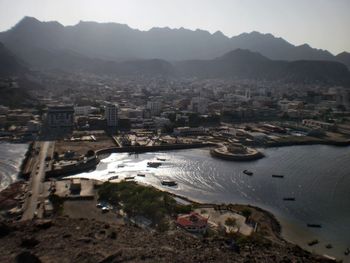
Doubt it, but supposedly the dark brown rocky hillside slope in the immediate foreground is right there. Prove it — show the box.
[0,217,334,263]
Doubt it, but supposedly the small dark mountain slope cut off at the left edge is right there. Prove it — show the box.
[0,43,25,77]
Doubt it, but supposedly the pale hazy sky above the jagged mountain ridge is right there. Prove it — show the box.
[0,0,350,54]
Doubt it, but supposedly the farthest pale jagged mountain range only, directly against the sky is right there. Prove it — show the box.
[0,17,348,67]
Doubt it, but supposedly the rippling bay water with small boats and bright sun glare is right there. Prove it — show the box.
[67,145,350,262]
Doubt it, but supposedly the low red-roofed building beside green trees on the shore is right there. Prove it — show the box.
[176,212,208,233]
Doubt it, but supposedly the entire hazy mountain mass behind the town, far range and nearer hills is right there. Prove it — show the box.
[0,17,349,84]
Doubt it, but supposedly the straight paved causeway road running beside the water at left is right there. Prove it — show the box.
[22,141,53,220]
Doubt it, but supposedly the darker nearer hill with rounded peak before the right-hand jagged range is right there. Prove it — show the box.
[174,49,350,85]
